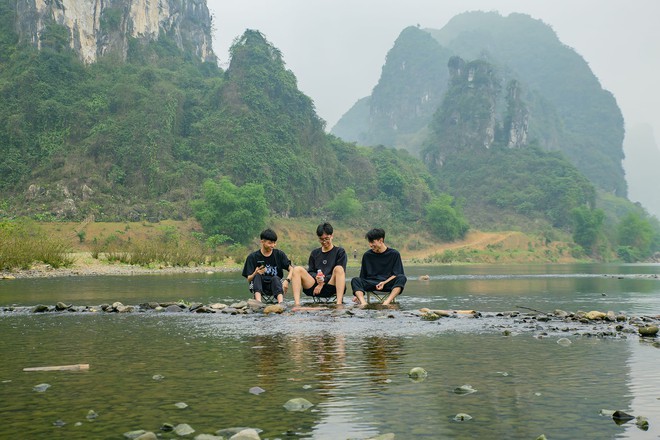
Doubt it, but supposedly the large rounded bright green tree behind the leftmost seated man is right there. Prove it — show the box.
[191,177,268,243]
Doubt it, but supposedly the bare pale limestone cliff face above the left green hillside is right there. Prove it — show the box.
[16,0,215,63]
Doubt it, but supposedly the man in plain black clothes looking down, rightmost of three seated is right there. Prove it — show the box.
[351,228,407,305]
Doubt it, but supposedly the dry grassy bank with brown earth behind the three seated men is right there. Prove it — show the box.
[11,218,575,267]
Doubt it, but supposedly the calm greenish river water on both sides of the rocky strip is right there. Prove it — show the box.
[0,265,660,440]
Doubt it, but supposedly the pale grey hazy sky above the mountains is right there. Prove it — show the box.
[208,0,660,139]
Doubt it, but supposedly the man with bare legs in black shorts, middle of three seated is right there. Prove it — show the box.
[291,223,348,306]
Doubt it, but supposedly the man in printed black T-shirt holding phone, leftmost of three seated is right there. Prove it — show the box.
[242,229,293,303]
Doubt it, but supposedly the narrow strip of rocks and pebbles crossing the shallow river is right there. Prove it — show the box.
[0,300,660,342]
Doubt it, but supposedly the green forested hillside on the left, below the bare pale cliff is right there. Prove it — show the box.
[0,10,433,227]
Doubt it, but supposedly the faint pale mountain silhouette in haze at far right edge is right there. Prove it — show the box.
[623,124,660,218]
